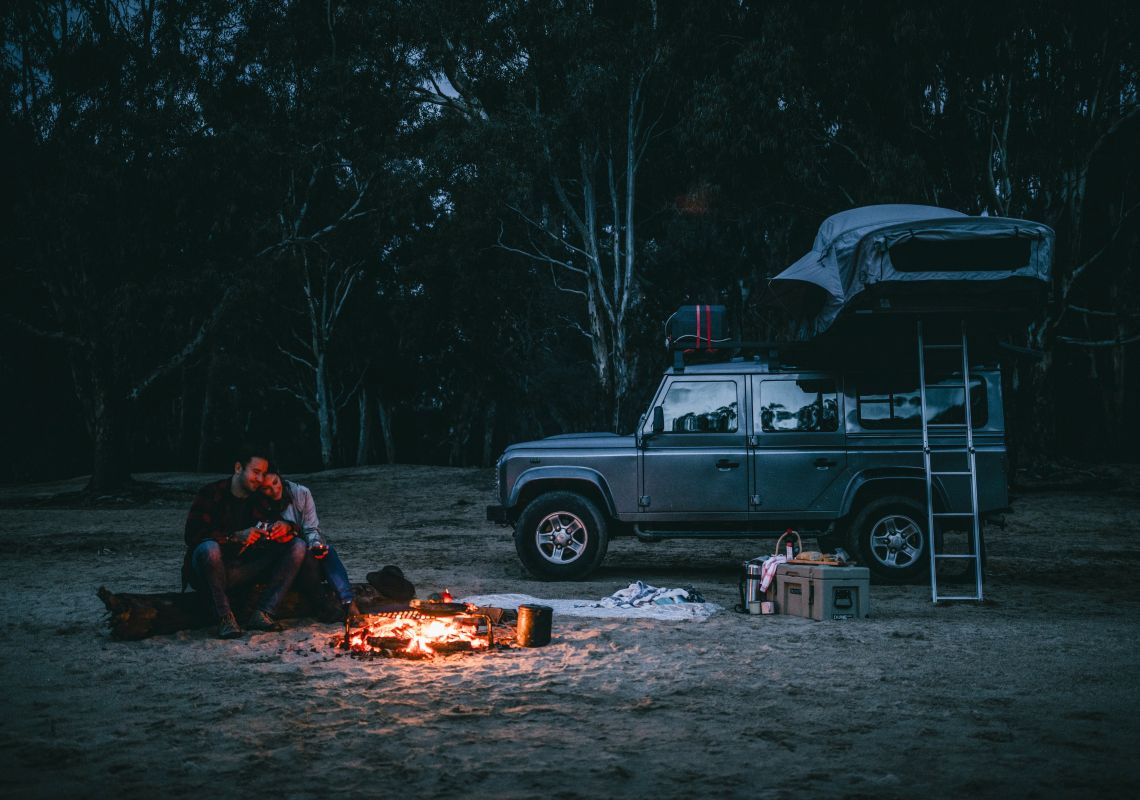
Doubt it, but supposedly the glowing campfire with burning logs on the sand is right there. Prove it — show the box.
[333,603,508,659]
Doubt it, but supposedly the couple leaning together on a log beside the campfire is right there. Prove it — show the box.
[182,447,357,639]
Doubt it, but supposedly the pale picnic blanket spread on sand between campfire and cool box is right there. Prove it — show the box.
[463,581,722,620]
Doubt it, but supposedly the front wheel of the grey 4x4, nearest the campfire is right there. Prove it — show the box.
[514,491,609,580]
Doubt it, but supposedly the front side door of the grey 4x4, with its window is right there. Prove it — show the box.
[640,375,748,519]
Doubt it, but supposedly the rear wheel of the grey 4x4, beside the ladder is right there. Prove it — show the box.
[852,496,930,583]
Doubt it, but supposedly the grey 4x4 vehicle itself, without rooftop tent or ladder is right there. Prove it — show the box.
[487,350,1008,580]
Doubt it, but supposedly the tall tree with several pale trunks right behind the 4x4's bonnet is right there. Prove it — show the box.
[403,2,698,427]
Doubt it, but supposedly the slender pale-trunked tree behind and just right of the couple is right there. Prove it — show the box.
[230,2,428,468]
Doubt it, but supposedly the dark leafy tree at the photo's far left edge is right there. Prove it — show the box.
[0,0,241,492]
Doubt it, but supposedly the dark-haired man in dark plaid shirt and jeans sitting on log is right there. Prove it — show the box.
[182,447,307,639]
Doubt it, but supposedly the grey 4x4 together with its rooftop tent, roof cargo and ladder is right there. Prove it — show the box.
[487,205,1055,583]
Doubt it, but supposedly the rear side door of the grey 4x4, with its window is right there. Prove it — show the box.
[751,375,847,514]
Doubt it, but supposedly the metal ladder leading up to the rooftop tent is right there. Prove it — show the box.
[918,320,983,603]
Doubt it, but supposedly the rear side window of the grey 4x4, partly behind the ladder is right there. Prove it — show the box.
[856,377,988,430]
